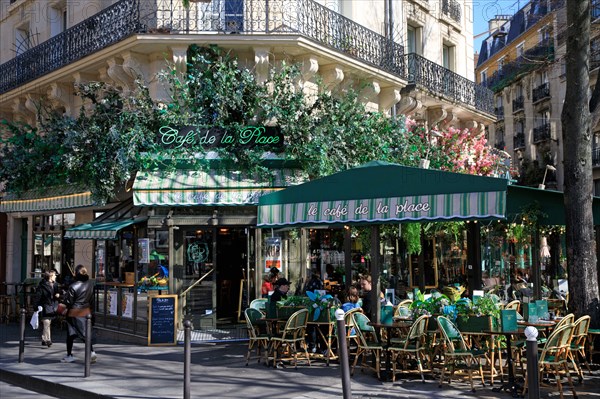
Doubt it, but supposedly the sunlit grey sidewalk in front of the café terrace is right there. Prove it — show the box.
[0,323,600,399]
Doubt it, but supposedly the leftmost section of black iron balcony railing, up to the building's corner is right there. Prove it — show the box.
[0,0,140,94]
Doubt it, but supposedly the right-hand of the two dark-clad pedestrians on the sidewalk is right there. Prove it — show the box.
[62,265,97,363]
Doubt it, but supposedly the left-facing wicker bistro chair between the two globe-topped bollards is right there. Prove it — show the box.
[388,315,429,383]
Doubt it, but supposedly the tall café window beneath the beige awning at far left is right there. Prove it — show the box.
[33,213,75,277]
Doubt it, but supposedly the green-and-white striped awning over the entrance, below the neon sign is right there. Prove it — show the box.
[133,169,305,206]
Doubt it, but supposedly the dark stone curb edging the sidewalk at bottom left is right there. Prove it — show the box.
[0,369,113,399]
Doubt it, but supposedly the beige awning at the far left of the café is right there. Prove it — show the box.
[0,186,94,213]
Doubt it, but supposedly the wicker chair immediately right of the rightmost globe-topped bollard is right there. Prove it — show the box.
[523,324,577,399]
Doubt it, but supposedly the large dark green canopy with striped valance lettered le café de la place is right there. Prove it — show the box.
[258,161,508,227]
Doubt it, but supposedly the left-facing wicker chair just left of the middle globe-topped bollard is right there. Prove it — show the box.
[271,309,310,369]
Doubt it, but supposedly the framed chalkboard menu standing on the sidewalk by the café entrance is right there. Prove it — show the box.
[148,295,177,345]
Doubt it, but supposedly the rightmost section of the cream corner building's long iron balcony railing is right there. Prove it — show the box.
[405,53,494,115]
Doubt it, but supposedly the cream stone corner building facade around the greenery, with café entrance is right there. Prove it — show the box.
[0,0,495,338]
